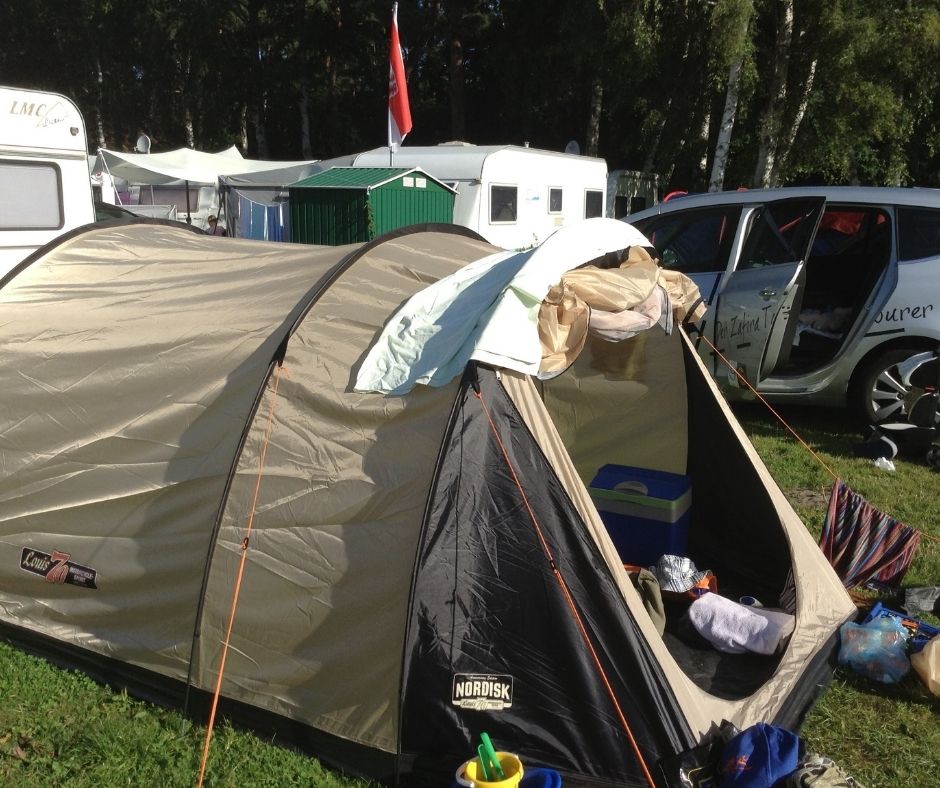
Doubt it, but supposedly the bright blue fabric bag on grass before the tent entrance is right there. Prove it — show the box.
[718,722,803,788]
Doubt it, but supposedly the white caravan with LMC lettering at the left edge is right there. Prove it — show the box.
[0,87,95,280]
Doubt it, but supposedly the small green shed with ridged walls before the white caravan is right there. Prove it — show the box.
[288,167,456,246]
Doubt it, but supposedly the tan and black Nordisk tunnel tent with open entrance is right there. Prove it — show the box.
[0,220,854,785]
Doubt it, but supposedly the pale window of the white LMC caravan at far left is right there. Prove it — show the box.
[0,162,64,230]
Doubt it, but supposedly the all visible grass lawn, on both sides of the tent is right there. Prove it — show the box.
[0,405,940,788]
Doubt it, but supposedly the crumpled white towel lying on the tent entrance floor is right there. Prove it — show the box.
[689,594,796,654]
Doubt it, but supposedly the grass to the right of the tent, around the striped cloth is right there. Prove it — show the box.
[735,404,940,788]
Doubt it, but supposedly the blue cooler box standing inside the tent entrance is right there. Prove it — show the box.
[588,465,692,566]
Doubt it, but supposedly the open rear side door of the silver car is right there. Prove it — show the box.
[714,197,826,386]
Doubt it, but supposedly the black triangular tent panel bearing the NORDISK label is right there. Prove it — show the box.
[402,368,692,785]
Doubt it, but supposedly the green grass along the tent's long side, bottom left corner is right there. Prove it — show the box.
[0,643,368,788]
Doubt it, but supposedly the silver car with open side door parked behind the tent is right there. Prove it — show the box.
[624,187,940,423]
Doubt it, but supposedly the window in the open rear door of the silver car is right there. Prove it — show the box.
[738,200,819,271]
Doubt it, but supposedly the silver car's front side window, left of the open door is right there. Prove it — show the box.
[634,205,741,274]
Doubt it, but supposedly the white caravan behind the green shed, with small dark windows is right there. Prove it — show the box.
[334,142,607,249]
